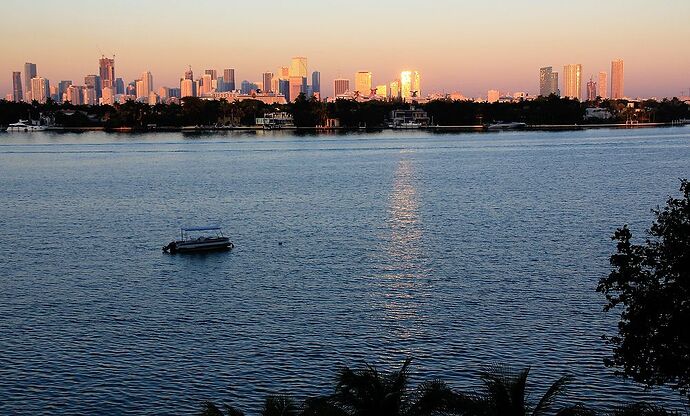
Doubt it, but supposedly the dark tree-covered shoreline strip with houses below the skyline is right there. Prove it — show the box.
[0,94,690,131]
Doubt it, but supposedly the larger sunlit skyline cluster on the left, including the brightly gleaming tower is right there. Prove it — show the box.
[6,56,421,105]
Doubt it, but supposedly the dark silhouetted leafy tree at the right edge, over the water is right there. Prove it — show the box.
[597,180,690,395]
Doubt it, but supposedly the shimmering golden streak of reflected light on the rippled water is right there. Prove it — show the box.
[381,159,428,338]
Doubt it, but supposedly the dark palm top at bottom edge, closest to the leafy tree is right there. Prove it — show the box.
[468,366,588,416]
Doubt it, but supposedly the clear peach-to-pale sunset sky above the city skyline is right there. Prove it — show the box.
[0,0,690,97]
